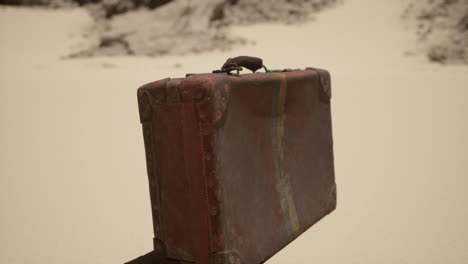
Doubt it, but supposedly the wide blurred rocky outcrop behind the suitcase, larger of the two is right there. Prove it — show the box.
[0,0,340,57]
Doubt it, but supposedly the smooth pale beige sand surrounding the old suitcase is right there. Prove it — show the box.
[0,0,468,264]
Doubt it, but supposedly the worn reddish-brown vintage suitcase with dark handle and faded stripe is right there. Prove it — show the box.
[138,57,336,264]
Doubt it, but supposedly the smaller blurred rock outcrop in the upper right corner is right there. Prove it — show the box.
[404,0,468,63]
